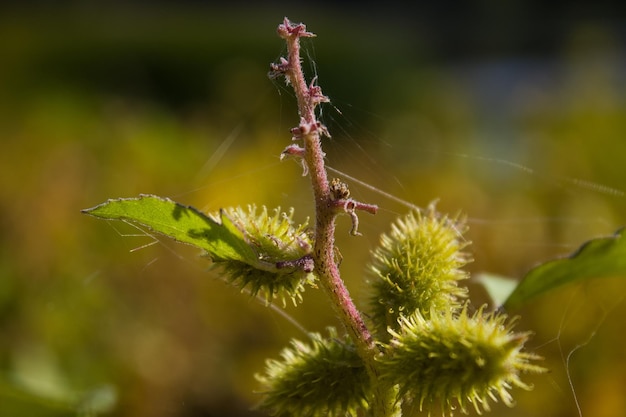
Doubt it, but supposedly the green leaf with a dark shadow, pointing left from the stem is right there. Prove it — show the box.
[83,195,258,264]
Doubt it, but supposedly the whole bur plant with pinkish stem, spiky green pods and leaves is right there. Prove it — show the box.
[84,19,626,417]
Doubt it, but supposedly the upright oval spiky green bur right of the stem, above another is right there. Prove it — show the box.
[370,208,470,338]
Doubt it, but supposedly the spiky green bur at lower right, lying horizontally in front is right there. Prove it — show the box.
[381,308,545,416]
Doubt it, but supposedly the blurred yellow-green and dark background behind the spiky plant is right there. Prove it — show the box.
[0,1,626,417]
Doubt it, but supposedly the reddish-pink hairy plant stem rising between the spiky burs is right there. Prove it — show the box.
[272,18,400,417]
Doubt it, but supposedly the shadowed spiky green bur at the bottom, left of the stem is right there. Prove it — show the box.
[257,328,370,417]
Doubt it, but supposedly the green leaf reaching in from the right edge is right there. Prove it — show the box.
[503,229,626,310]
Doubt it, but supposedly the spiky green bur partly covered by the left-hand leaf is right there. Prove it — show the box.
[216,205,315,304]
